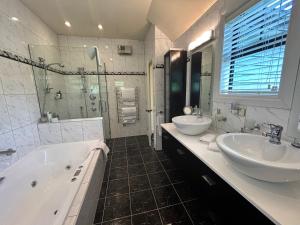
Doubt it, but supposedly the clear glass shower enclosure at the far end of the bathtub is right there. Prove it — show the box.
[29,45,111,138]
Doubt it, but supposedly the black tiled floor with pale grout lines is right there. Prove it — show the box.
[94,136,214,225]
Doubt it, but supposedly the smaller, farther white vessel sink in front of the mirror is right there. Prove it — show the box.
[172,115,212,135]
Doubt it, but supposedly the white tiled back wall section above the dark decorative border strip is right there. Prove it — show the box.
[58,35,144,72]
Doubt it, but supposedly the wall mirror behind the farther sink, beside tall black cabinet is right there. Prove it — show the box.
[190,45,213,115]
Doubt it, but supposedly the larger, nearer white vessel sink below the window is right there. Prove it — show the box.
[217,133,300,182]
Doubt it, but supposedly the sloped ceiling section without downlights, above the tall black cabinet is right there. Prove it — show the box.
[148,0,217,41]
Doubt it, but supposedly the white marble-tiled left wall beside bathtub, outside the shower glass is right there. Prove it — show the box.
[0,0,57,170]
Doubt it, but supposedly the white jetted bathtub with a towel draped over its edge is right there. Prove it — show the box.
[0,140,108,225]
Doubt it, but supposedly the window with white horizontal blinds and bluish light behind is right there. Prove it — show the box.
[220,0,293,96]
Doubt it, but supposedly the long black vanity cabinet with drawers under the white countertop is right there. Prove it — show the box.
[162,129,273,225]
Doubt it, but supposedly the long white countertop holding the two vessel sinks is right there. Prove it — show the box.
[161,123,300,225]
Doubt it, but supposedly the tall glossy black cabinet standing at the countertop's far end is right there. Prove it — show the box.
[164,49,187,122]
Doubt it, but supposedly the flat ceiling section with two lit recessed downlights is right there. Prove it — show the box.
[21,0,151,40]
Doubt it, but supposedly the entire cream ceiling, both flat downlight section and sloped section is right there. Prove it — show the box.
[21,0,216,40]
